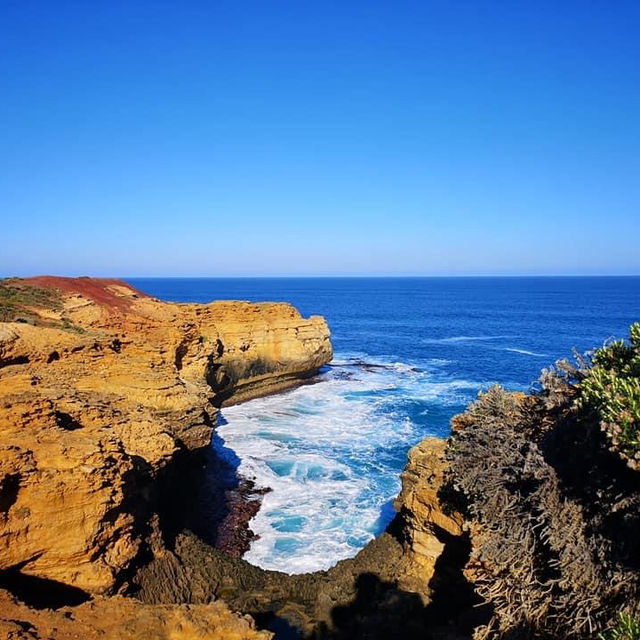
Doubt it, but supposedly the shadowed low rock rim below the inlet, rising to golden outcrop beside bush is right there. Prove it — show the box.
[133,438,469,639]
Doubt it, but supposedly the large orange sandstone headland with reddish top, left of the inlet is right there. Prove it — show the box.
[0,277,332,594]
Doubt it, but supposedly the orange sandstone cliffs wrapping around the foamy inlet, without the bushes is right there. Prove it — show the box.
[0,277,468,640]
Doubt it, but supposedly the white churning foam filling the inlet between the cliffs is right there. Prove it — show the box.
[218,354,478,573]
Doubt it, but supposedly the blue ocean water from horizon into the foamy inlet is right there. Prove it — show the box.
[128,277,640,573]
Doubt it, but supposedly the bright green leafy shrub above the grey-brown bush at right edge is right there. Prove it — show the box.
[578,323,640,469]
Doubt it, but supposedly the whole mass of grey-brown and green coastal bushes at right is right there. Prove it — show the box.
[448,324,640,639]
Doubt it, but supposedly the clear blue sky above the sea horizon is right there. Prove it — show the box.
[0,0,640,276]
